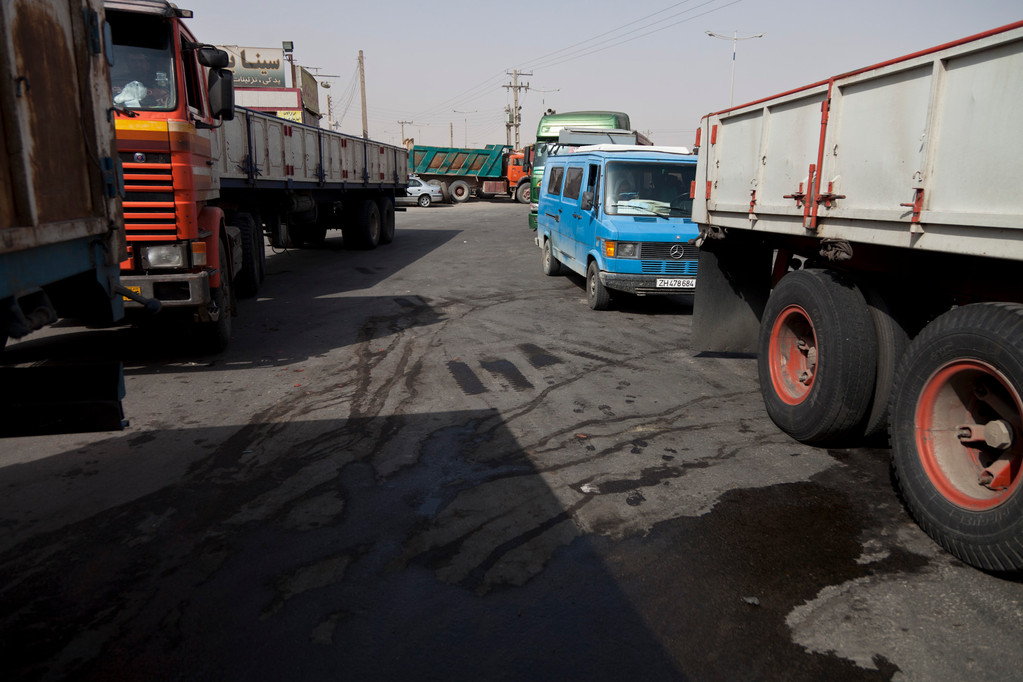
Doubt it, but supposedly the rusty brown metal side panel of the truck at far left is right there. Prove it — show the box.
[0,0,124,253]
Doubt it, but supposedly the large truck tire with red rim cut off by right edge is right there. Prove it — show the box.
[891,304,1023,574]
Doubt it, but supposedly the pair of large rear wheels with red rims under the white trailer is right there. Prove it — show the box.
[758,270,1023,573]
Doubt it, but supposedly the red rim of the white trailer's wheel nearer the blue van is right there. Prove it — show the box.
[767,306,818,405]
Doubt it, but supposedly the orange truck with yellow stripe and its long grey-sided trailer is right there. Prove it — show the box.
[105,0,408,352]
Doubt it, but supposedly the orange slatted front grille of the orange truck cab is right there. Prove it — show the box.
[121,152,177,241]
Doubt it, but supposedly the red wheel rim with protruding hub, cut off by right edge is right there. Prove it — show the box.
[915,360,1023,511]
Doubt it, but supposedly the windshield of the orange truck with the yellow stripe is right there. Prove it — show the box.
[107,11,177,111]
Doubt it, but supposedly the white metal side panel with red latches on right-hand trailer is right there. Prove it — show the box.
[694,25,1023,260]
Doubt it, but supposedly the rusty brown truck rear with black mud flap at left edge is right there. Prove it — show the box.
[0,0,126,437]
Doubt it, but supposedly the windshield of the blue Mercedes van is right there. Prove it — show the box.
[604,162,697,218]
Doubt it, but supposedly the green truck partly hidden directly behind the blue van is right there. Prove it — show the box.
[526,111,651,231]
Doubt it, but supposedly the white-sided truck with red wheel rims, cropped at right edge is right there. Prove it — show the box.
[693,22,1023,573]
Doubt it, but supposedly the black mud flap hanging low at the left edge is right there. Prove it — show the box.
[0,362,128,438]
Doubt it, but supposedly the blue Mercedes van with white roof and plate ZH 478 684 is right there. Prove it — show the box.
[536,149,700,310]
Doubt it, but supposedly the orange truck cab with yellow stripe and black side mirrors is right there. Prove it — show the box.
[105,0,241,351]
